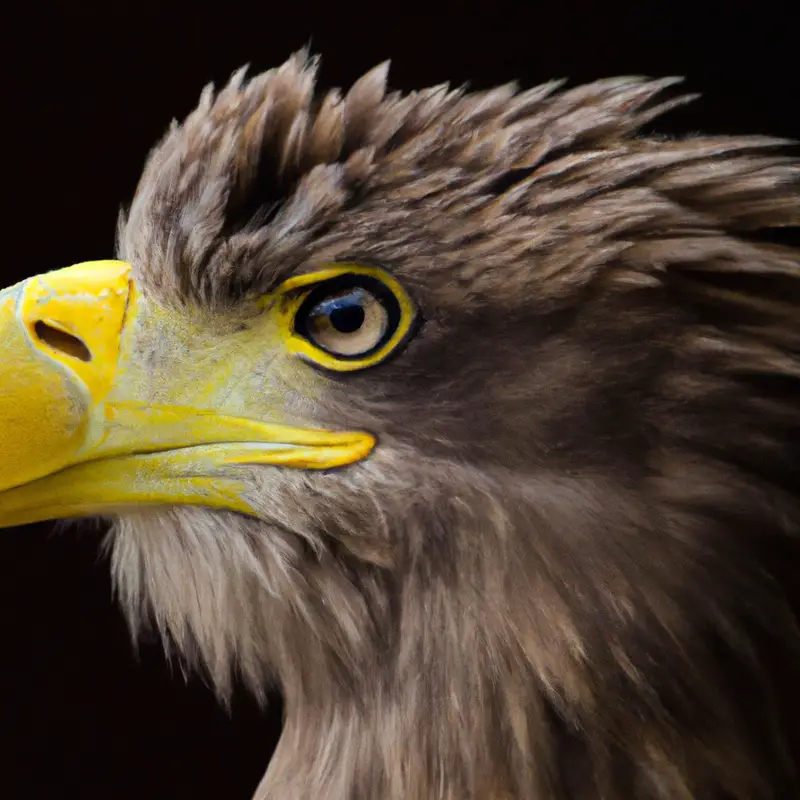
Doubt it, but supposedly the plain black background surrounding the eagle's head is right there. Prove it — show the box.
[0,0,800,800]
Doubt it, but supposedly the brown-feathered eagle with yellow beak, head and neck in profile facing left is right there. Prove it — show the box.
[0,50,800,800]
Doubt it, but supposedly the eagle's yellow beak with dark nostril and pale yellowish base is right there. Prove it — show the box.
[0,261,375,527]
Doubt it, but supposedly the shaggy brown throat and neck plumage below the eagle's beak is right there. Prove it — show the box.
[114,454,786,800]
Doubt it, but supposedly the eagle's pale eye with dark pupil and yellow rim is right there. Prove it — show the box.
[278,264,416,372]
